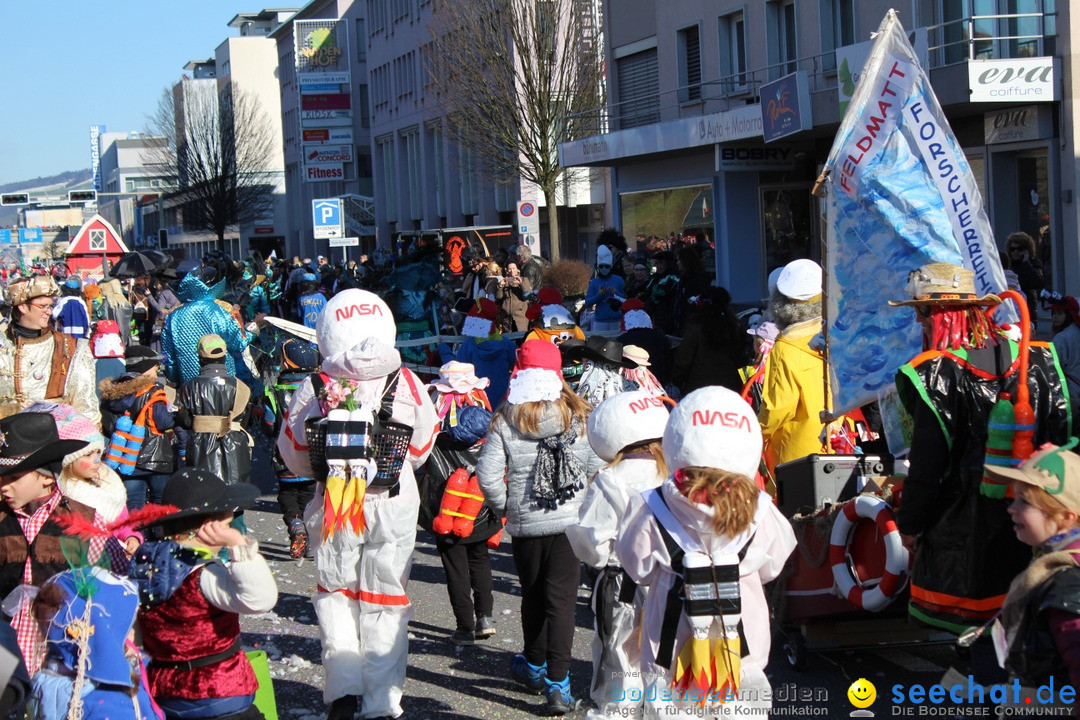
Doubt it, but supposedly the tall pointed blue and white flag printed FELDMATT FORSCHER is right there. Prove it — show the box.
[824,10,1005,415]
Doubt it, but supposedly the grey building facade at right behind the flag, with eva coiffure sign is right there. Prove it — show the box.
[562,0,1067,300]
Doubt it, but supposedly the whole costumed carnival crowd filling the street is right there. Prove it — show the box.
[0,232,1080,720]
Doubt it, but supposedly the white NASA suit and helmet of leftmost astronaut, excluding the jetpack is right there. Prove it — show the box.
[278,289,438,718]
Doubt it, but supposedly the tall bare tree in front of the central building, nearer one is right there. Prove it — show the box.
[423,0,603,261]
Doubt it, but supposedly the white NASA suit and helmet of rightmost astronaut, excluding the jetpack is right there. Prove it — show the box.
[616,386,795,719]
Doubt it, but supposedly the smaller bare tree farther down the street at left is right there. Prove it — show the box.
[144,80,274,249]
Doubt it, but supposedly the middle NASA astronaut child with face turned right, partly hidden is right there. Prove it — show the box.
[566,391,667,718]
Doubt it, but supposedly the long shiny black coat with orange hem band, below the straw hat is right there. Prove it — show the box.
[896,341,1070,630]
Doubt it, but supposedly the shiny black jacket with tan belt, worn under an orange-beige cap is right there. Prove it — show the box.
[176,364,252,485]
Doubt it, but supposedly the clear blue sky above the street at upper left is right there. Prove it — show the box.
[0,0,268,184]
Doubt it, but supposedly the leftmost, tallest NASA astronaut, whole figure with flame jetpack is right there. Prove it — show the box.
[278,288,438,720]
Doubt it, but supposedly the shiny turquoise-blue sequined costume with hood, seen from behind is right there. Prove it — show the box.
[161,272,262,395]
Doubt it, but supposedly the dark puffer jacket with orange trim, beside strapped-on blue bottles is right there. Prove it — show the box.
[97,376,176,476]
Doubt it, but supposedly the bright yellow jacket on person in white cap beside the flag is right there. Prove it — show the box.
[758,318,833,473]
